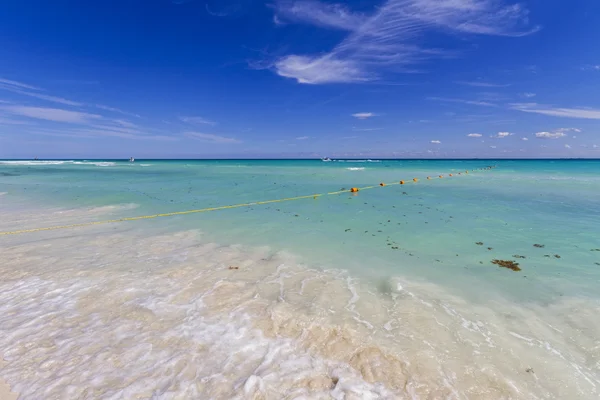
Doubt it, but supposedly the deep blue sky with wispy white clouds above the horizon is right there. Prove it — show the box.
[0,0,600,158]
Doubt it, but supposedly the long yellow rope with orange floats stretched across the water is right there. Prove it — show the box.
[0,168,488,236]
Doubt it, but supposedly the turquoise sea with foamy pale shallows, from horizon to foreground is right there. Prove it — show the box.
[0,160,600,399]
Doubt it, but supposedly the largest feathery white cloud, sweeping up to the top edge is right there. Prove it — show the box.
[272,0,539,84]
